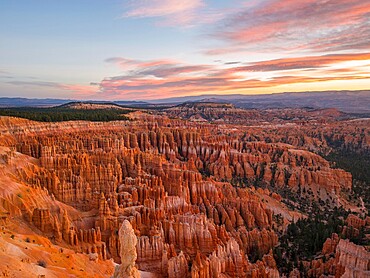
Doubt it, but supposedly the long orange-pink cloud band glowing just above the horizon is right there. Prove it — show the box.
[100,53,370,99]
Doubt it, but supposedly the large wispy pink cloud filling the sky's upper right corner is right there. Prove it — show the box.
[206,0,370,55]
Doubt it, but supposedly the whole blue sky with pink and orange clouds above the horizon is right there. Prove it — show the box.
[0,0,370,100]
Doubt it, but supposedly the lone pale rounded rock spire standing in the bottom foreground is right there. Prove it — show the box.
[113,220,140,278]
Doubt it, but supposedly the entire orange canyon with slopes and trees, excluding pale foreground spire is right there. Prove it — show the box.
[0,103,370,277]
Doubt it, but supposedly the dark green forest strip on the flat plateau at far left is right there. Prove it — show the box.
[0,107,132,122]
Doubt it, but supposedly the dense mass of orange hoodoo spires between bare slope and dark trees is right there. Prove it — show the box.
[0,112,366,277]
